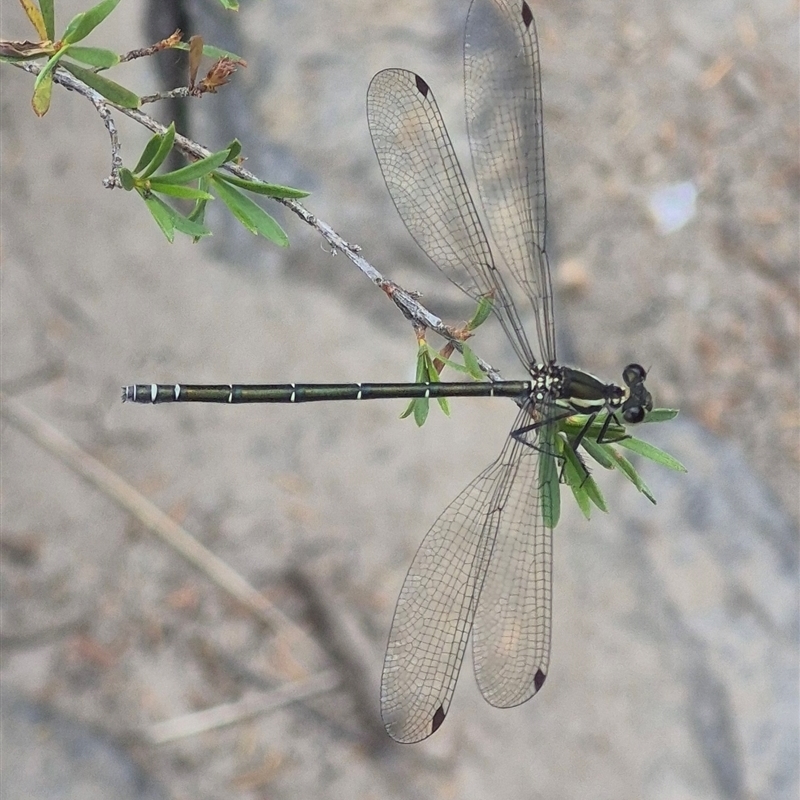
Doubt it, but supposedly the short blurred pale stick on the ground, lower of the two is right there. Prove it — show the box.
[142,671,340,744]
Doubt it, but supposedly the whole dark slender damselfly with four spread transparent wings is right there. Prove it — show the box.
[123,0,652,742]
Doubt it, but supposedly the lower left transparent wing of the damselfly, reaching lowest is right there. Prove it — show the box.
[381,410,550,742]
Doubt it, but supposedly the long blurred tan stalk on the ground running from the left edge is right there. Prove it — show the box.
[0,392,319,652]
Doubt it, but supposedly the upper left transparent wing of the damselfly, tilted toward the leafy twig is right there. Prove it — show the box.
[367,69,535,368]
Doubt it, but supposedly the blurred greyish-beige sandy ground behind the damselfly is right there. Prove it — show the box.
[0,0,800,800]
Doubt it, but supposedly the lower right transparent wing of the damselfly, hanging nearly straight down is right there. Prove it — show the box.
[472,410,558,708]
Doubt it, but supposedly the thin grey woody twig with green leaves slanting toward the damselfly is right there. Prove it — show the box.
[9,61,502,381]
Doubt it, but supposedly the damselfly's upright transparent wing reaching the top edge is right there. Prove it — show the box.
[464,0,556,361]
